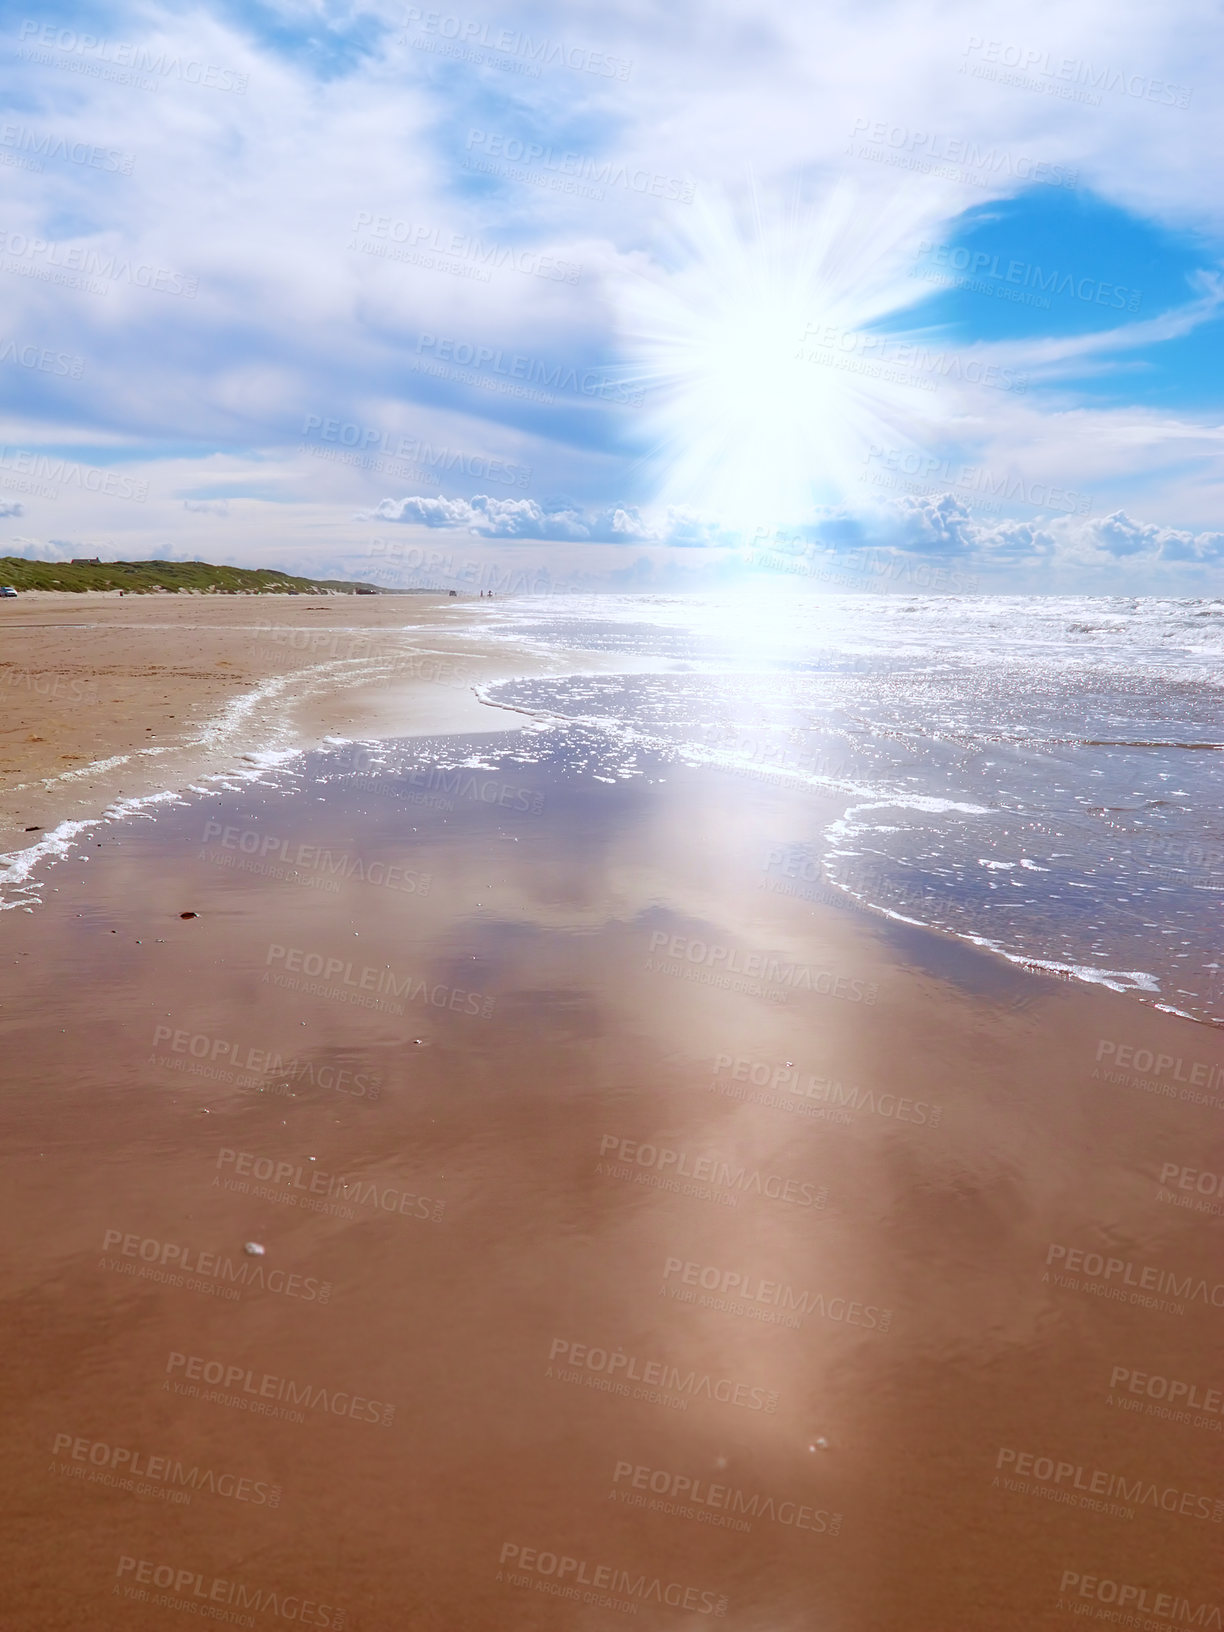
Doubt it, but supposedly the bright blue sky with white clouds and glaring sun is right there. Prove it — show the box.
[0,0,1224,596]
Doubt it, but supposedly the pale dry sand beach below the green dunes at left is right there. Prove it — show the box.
[0,592,535,852]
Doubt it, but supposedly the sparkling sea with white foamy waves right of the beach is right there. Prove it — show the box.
[453,592,1224,1023]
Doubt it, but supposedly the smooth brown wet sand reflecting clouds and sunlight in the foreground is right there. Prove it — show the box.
[0,736,1224,1632]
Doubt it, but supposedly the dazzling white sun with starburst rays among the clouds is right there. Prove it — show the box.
[617,186,947,535]
